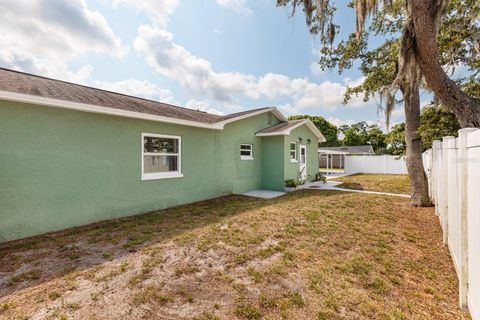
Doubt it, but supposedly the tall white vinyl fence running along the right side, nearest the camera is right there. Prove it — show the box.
[423,128,480,320]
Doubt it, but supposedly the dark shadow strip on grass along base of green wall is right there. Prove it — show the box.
[0,190,339,298]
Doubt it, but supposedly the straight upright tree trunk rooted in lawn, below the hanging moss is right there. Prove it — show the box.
[400,85,432,207]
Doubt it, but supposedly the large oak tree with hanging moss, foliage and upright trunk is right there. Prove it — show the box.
[277,0,480,206]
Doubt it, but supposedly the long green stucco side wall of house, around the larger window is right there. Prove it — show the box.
[0,101,284,242]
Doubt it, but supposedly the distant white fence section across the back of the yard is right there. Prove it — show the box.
[345,155,407,174]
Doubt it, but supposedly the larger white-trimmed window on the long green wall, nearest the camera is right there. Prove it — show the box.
[142,133,182,180]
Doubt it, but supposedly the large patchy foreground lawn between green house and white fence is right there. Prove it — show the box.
[0,190,468,319]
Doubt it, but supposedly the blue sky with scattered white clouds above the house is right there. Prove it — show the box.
[0,0,412,125]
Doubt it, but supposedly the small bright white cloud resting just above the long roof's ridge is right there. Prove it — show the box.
[93,79,178,104]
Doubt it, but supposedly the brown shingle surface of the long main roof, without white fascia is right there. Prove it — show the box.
[0,68,266,124]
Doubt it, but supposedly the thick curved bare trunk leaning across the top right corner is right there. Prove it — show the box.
[410,0,480,128]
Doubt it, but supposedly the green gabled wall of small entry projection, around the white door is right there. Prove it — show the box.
[284,125,319,180]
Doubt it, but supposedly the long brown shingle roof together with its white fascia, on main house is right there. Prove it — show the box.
[0,68,286,129]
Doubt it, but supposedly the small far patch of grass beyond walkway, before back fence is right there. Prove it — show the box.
[334,173,410,194]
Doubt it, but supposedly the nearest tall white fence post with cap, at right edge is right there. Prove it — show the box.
[457,128,476,309]
